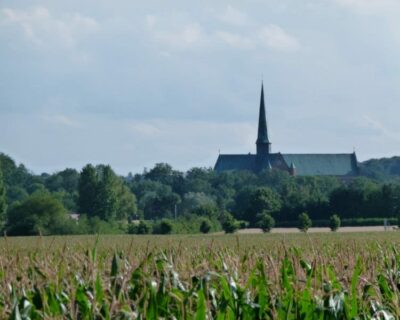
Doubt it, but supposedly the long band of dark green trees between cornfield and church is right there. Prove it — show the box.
[0,154,400,235]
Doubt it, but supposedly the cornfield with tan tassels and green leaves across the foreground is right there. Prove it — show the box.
[0,232,400,319]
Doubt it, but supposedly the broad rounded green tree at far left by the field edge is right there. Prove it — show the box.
[6,194,69,235]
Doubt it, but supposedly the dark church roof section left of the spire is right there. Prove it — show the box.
[214,154,256,171]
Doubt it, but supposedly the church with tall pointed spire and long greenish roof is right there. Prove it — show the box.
[214,85,358,178]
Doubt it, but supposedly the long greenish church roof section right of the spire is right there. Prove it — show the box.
[282,153,358,176]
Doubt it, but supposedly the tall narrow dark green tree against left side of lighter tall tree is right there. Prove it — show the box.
[78,164,98,217]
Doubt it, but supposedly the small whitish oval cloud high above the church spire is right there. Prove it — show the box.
[258,24,300,51]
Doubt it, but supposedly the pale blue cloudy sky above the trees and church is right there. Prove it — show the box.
[0,0,400,174]
